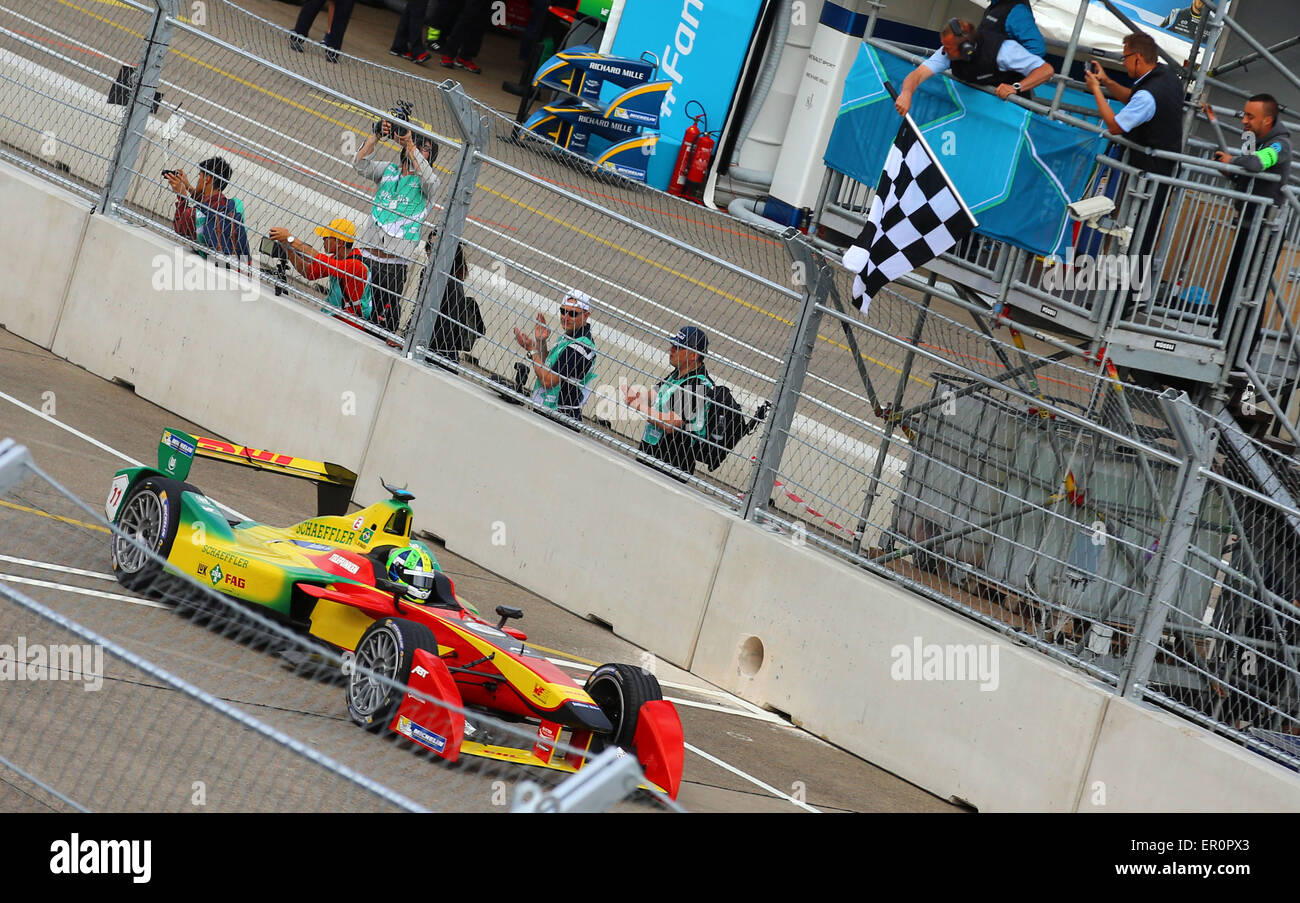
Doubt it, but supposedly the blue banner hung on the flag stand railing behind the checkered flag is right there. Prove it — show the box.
[826,44,1106,256]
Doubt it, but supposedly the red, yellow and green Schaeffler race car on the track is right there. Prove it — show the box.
[105,430,685,798]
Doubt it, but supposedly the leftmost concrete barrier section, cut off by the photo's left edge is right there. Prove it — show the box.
[0,166,91,348]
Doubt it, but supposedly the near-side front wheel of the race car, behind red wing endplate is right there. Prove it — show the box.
[347,617,438,731]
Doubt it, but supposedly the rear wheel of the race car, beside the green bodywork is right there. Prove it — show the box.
[112,477,192,592]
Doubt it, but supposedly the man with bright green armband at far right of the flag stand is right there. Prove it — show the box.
[1214,94,1291,328]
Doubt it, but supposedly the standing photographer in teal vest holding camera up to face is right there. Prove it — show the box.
[352,120,438,331]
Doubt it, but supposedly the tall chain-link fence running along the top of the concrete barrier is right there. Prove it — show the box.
[10,0,1300,779]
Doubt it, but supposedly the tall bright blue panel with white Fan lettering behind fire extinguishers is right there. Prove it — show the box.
[601,0,763,188]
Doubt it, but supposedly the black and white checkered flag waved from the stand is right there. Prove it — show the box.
[844,116,979,313]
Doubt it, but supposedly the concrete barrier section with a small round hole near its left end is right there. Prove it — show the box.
[692,522,1109,812]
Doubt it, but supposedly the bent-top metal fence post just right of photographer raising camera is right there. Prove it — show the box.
[402,83,491,357]
